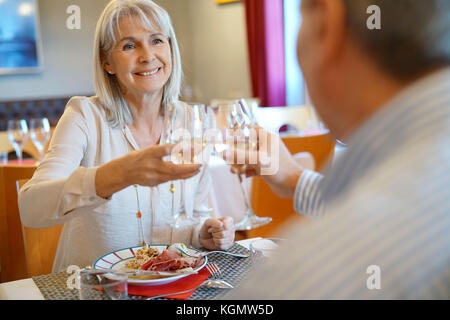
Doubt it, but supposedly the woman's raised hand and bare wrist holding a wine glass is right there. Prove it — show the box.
[95,144,201,198]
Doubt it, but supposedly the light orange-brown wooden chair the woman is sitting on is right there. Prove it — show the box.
[17,179,63,278]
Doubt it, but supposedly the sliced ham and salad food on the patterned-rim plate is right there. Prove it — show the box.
[121,243,203,274]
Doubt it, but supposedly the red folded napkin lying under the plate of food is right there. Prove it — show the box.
[128,268,210,300]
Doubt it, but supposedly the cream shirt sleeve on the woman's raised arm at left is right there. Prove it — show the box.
[18,98,109,228]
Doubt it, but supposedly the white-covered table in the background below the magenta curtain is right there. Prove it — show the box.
[254,106,320,132]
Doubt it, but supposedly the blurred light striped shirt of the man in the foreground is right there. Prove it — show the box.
[227,68,450,299]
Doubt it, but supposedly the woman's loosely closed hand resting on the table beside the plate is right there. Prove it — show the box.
[199,217,235,250]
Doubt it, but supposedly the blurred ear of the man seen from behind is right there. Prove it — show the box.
[315,0,347,65]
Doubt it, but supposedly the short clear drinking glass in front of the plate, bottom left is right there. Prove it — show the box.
[78,269,128,300]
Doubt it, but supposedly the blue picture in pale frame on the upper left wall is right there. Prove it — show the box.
[0,0,42,75]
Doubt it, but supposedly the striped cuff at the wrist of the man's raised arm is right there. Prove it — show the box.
[294,170,324,218]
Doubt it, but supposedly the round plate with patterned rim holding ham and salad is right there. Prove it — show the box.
[93,243,208,286]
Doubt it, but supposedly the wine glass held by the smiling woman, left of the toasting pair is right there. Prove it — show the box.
[163,104,203,229]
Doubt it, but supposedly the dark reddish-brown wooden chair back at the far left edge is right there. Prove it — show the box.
[0,164,36,282]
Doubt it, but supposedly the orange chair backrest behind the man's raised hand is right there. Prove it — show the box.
[246,132,335,238]
